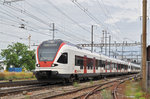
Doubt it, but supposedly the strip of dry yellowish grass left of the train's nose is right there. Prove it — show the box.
[0,72,35,80]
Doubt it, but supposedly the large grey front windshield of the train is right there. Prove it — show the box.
[38,42,60,61]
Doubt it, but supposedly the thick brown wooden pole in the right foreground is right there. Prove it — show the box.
[142,0,147,91]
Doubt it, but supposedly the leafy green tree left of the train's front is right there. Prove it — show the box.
[1,43,35,70]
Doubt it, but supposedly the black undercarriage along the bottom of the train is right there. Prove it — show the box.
[35,71,138,83]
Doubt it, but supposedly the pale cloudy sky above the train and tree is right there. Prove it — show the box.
[0,0,150,58]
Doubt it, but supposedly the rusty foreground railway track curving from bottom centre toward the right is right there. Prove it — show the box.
[36,75,139,99]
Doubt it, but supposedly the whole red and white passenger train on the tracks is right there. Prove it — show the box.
[35,40,141,81]
